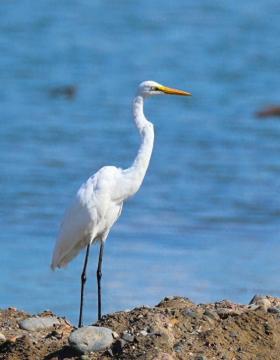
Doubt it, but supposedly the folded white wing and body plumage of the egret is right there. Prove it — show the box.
[51,166,123,269]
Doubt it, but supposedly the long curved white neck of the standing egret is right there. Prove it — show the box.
[122,95,154,197]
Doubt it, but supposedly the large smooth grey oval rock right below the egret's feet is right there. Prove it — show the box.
[68,326,114,353]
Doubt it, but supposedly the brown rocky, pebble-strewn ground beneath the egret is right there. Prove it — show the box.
[0,296,280,360]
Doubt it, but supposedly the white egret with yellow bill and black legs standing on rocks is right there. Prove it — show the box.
[51,81,191,327]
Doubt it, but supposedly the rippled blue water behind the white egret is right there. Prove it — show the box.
[0,0,280,322]
